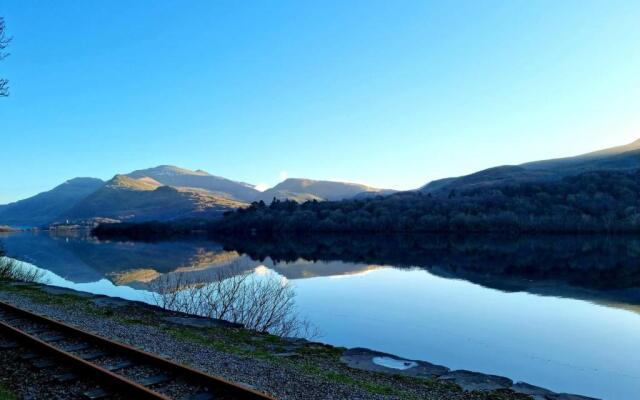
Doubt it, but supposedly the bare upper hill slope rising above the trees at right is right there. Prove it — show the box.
[419,140,640,194]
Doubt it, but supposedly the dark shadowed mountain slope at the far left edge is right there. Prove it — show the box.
[0,178,104,226]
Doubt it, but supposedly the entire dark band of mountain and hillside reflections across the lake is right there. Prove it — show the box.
[0,232,640,311]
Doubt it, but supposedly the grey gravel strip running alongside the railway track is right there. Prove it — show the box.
[0,282,528,400]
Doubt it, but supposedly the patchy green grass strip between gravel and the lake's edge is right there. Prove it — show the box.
[0,282,529,400]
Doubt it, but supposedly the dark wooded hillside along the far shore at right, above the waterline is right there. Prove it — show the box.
[209,171,640,234]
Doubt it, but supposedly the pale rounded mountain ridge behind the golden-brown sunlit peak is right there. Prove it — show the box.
[127,165,260,202]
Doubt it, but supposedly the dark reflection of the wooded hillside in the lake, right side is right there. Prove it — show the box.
[218,235,640,311]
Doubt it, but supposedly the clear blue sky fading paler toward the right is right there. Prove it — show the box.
[0,0,640,203]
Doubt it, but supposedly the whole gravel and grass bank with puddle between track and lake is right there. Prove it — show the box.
[0,283,600,400]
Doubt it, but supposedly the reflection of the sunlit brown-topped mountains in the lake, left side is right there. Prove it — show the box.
[0,232,252,287]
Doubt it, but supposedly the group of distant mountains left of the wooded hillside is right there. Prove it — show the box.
[0,165,393,227]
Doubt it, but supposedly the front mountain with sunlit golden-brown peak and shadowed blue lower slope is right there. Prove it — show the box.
[62,175,246,221]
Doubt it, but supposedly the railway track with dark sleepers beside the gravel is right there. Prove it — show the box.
[0,302,275,400]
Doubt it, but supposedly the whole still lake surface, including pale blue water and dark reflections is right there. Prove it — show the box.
[0,232,640,400]
